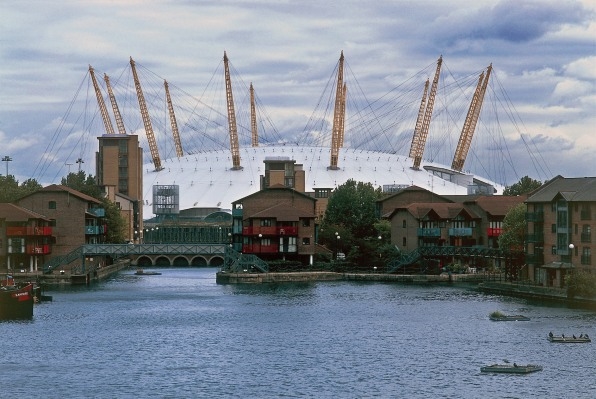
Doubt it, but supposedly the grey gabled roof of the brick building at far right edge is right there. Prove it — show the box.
[526,176,596,203]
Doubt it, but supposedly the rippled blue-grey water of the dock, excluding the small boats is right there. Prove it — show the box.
[0,268,596,398]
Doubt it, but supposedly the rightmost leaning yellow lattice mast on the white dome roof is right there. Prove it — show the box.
[451,64,493,172]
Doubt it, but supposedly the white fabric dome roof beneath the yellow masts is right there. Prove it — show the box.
[143,145,503,219]
